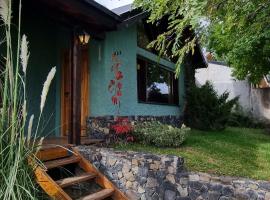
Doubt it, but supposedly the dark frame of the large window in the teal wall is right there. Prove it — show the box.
[136,55,180,106]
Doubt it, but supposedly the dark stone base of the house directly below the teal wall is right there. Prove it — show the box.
[86,115,183,139]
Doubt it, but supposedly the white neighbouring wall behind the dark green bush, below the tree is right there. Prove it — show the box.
[195,62,270,121]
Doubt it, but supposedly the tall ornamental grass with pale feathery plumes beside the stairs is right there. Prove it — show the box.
[0,0,56,200]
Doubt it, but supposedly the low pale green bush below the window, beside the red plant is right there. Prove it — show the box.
[133,121,190,147]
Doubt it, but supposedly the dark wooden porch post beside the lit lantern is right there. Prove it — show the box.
[69,32,81,145]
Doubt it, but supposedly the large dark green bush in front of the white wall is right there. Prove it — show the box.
[185,81,238,130]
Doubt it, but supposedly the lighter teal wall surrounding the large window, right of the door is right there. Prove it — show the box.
[90,25,184,116]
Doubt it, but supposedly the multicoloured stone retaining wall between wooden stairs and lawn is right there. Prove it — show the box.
[78,146,270,200]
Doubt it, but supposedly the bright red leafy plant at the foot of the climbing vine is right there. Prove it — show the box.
[111,117,134,142]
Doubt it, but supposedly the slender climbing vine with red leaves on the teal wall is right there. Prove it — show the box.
[108,51,124,114]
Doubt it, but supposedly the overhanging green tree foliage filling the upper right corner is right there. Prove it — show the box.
[135,0,270,83]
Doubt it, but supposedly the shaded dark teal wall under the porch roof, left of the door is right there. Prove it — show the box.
[22,16,70,136]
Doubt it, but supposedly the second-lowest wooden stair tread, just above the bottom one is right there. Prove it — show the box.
[55,173,96,188]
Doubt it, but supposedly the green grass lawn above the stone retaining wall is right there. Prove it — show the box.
[115,128,270,181]
